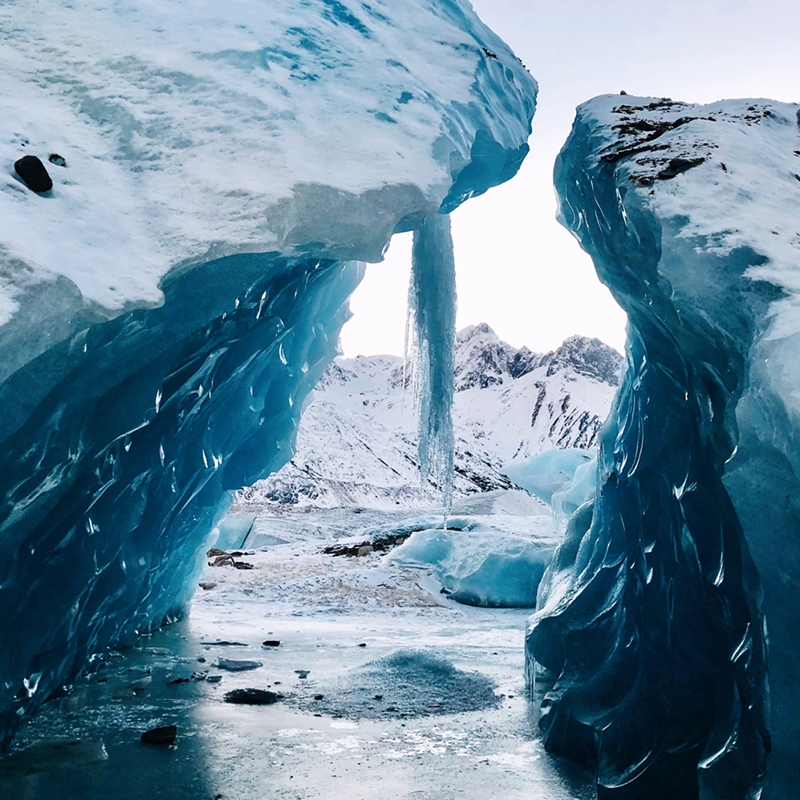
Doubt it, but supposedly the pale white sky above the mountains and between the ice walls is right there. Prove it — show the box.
[341,0,800,356]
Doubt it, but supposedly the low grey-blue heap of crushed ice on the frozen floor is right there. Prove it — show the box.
[289,649,500,719]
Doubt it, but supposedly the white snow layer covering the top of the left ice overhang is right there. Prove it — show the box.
[0,0,535,324]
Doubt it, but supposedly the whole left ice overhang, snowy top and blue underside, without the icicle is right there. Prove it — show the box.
[0,0,537,743]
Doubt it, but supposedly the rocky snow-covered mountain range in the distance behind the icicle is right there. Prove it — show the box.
[237,323,622,507]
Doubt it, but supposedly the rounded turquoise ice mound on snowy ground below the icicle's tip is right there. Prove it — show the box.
[386,516,555,608]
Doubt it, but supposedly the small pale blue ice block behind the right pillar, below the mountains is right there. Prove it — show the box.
[503,448,597,520]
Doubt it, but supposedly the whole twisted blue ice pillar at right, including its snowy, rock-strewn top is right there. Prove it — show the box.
[526,95,800,800]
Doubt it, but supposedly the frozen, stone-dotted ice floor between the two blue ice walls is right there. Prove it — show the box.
[0,502,594,800]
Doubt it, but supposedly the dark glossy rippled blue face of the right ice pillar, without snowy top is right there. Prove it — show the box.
[526,97,784,800]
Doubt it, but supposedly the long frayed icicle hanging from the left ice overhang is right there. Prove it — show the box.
[406,214,456,515]
